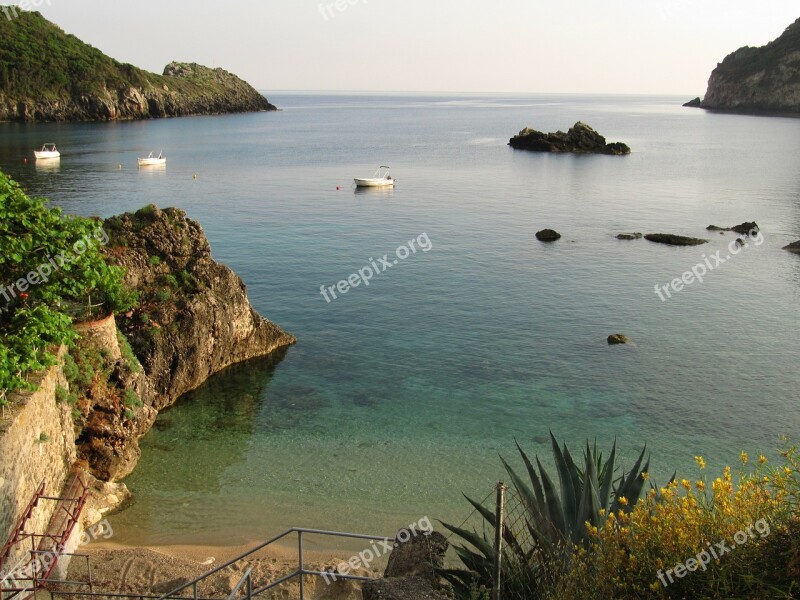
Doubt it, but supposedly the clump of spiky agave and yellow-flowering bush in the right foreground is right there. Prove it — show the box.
[442,442,800,600]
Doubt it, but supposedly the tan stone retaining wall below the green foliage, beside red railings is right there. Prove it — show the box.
[0,347,76,566]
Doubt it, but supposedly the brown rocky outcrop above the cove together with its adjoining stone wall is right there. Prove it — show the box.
[0,205,296,551]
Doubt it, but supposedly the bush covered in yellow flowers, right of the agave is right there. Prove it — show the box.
[554,440,800,600]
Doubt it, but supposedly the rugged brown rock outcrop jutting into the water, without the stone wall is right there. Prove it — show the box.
[73,205,295,481]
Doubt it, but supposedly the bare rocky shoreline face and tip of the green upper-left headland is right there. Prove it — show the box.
[0,62,277,121]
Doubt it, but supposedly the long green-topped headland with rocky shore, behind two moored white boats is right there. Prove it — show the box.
[0,10,277,121]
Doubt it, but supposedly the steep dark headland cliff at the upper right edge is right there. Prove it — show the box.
[701,19,800,114]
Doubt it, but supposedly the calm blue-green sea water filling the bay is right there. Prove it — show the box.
[0,94,800,544]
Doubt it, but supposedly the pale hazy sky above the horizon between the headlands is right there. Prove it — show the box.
[31,0,800,96]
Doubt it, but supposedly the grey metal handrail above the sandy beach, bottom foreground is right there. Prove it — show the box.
[49,527,394,600]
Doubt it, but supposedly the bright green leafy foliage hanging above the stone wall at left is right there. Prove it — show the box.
[0,173,136,406]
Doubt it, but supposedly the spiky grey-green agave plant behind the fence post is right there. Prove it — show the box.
[441,432,650,600]
